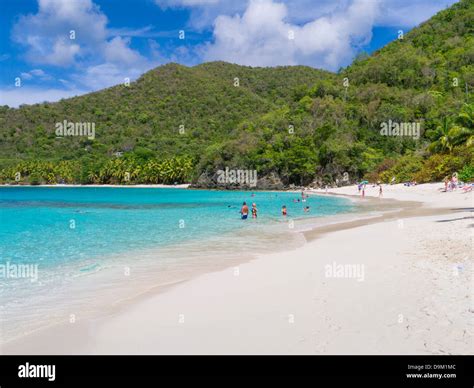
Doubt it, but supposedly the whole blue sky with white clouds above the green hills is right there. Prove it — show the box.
[0,0,455,107]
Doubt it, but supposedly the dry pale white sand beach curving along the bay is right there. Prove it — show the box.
[0,184,474,354]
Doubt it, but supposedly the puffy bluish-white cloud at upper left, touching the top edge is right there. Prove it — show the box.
[12,0,151,68]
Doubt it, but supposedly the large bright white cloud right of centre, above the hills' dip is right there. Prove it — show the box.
[204,0,379,70]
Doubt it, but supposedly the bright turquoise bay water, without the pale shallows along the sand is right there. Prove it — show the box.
[0,187,350,266]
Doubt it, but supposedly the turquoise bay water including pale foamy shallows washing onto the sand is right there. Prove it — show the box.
[0,187,353,342]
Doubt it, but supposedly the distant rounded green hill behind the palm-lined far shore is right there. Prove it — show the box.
[0,63,325,159]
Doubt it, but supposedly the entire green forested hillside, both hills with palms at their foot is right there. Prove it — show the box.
[0,0,474,184]
